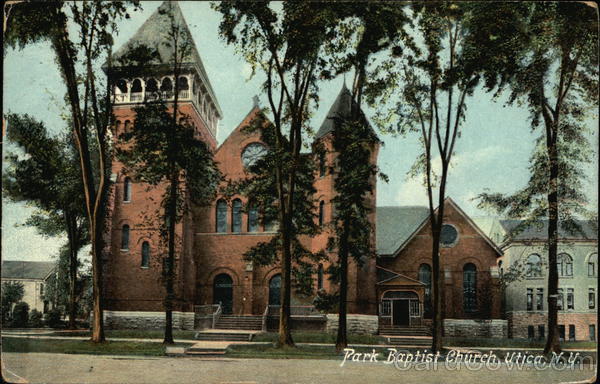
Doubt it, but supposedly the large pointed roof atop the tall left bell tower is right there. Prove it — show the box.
[113,1,222,114]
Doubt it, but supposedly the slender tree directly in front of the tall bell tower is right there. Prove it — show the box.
[117,101,221,343]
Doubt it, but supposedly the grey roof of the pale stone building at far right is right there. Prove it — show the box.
[500,220,598,241]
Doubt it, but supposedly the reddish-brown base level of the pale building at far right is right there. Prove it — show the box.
[507,311,598,341]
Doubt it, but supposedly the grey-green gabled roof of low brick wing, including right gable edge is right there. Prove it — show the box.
[377,197,502,256]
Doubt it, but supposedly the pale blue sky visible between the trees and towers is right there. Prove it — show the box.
[2,2,598,260]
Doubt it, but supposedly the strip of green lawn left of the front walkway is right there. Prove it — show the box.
[2,337,176,356]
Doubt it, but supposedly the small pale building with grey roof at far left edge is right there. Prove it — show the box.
[2,260,56,313]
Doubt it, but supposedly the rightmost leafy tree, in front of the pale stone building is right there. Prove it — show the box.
[476,2,598,354]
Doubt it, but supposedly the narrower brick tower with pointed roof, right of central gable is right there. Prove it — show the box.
[313,83,379,314]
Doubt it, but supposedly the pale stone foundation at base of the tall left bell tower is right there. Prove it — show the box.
[104,311,194,329]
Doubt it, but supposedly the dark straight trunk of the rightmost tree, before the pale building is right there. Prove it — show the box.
[544,133,564,354]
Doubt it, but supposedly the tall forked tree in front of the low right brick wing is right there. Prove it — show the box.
[366,2,518,351]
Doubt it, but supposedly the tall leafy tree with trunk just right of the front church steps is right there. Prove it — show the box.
[215,1,346,346]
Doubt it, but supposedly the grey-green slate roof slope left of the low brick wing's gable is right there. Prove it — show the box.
[376,206,429,256]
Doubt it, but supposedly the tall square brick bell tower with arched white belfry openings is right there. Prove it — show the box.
[103,1,222,328]
